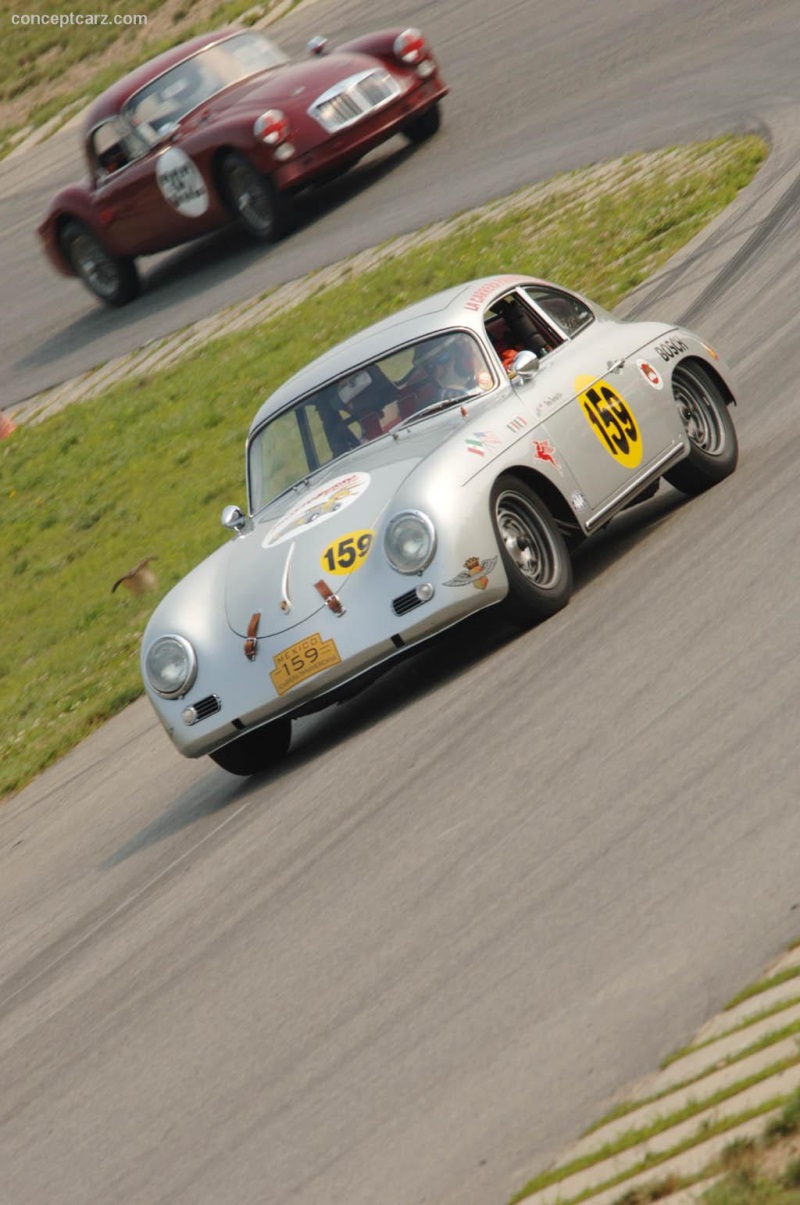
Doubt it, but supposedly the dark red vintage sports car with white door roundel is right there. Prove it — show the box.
[39,29,447,306]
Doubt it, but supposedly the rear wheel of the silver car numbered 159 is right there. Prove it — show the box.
[664,364,739,494]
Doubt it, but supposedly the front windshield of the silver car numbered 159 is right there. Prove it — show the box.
[247,331,496,513]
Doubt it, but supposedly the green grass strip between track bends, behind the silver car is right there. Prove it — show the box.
[0,137,765,798]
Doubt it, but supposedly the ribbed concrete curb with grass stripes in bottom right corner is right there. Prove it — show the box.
[513,948,800,1205]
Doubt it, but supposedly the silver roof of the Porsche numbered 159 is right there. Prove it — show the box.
[251,275,539,431]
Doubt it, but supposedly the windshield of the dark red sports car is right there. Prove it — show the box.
[123,33,288,146]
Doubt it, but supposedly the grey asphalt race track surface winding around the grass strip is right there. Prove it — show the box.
[0,0,800,1205]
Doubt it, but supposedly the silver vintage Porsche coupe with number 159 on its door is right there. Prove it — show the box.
[142,275,737,775]
